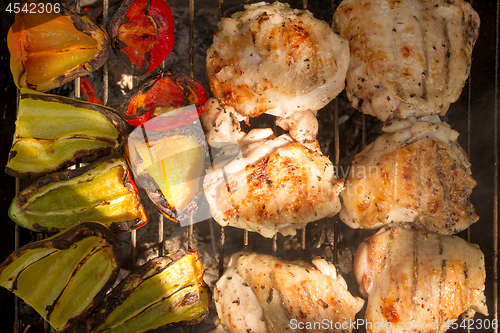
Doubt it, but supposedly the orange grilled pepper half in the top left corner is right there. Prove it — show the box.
[7,0,110,91]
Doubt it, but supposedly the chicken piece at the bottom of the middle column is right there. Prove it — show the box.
[213,253,364,333]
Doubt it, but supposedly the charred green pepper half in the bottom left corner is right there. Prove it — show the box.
[0,222,120,331]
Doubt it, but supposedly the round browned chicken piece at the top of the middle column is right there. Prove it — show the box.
[207,2,349,118]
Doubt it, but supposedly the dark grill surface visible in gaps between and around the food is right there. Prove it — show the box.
[0,0,500,333]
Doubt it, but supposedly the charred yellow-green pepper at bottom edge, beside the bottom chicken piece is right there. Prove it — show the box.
[86,250,211,333]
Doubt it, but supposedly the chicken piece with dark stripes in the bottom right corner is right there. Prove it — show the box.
[354,226,488,333]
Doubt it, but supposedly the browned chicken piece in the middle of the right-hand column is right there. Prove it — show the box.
[340,116,478,235]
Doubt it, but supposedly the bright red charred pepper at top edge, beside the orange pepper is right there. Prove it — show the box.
[109,0,175,75]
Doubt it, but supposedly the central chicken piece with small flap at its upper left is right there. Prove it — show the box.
[201,97,344,237]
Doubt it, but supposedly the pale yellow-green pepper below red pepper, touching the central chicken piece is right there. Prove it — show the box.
[126,107,209,222]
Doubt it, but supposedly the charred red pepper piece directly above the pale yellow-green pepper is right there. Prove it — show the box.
[120,71,208,127]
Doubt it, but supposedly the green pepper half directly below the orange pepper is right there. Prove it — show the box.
[5,89,126,178]
